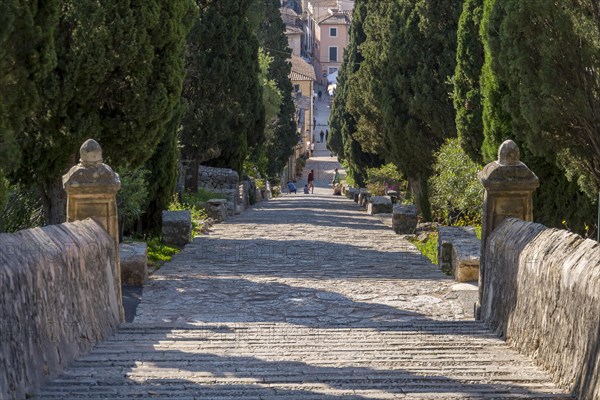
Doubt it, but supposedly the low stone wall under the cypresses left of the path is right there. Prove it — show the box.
[198,165,240,215]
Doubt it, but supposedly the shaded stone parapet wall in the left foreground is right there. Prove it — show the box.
[0,219,119,399]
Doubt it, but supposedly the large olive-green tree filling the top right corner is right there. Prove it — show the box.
[490,0,600,199]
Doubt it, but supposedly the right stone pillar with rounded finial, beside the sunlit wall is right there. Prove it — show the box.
[476,140,539,315]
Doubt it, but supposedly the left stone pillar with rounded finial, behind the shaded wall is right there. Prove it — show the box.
[63,139,125,321]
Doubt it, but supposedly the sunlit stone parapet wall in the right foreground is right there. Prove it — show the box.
[481,219,600,400]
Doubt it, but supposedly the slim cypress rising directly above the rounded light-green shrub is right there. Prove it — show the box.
[453,0,484,162]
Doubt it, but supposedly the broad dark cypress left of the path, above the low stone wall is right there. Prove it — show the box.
[182,0,264,178]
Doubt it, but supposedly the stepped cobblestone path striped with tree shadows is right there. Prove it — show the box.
[37,159,566,400]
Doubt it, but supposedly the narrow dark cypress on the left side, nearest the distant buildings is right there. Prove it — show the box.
[257,0,299,176]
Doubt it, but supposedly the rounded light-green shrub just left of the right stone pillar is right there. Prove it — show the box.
[429,138,483,225]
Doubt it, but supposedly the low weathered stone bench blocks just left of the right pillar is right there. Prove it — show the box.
[438,226,481,282]
